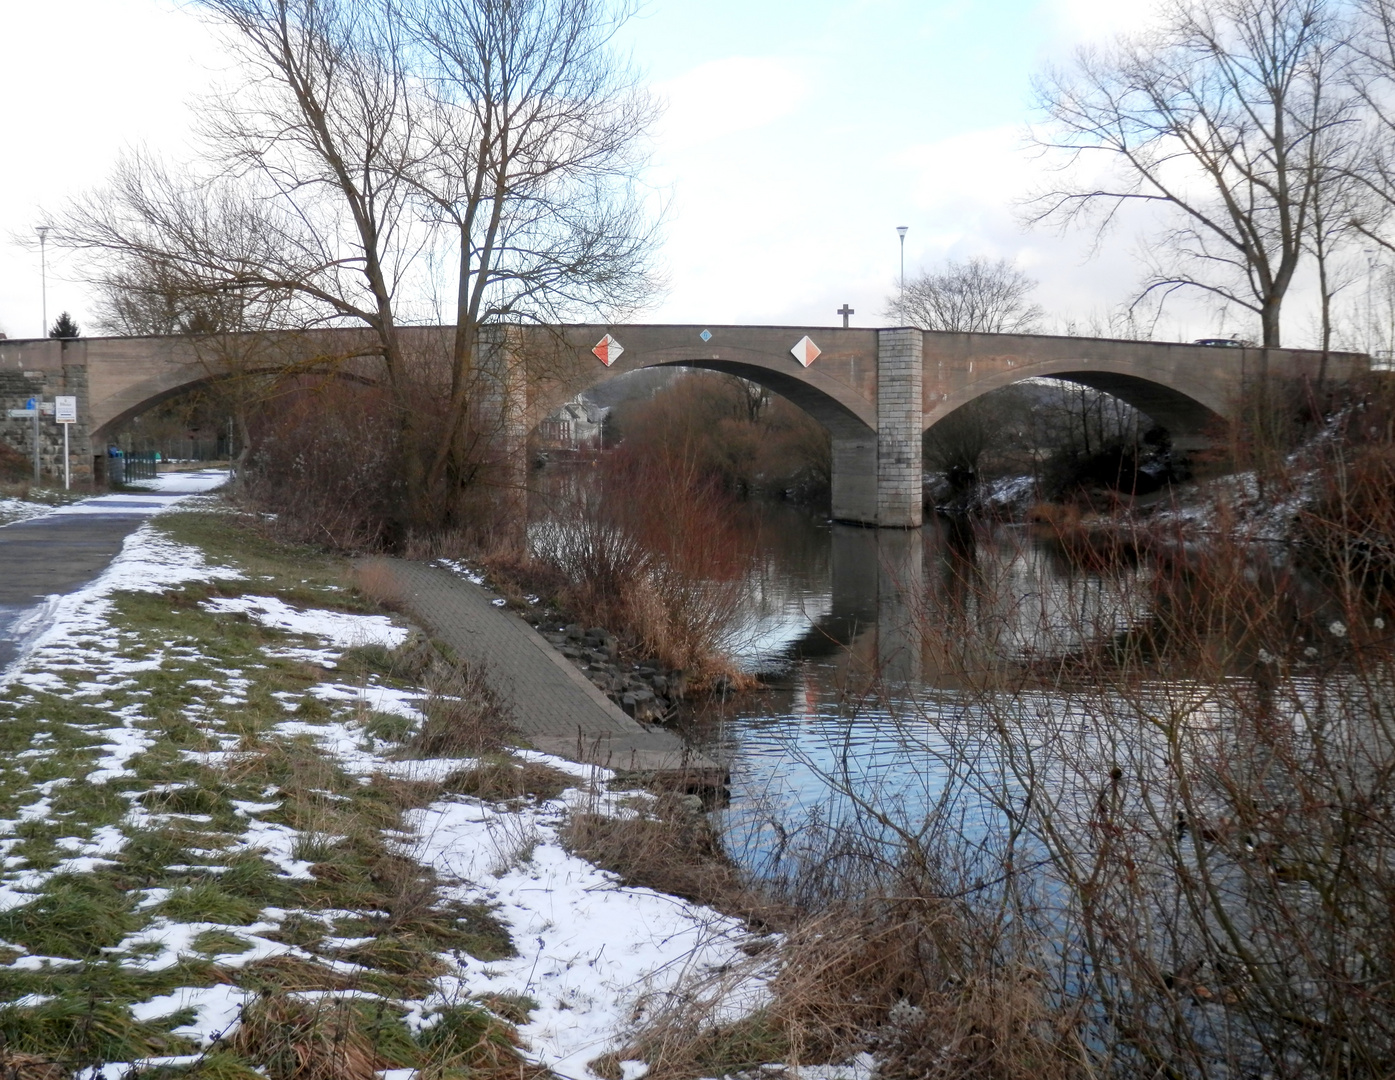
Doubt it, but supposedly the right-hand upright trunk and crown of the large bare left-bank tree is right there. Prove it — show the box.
[399,0,656,499]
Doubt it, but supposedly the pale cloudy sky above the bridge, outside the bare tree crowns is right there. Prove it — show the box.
[0,0,1226,344]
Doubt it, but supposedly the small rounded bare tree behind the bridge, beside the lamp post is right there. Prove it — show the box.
[886,257,1042,333]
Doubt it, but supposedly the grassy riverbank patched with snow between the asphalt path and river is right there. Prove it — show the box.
[0,508,766,1079]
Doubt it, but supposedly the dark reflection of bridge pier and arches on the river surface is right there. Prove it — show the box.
[734,507,1148,692]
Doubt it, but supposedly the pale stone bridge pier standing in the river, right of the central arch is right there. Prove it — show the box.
[831,327,925,529]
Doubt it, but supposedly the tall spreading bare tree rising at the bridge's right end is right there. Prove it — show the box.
[1034,0,1356,346]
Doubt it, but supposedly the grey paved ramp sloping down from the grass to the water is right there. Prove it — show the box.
[372,560,725,788]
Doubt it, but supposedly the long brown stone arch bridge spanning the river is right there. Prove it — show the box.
[0,324,1370,527]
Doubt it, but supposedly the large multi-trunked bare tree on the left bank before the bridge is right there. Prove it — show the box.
[46,0,653,526]
